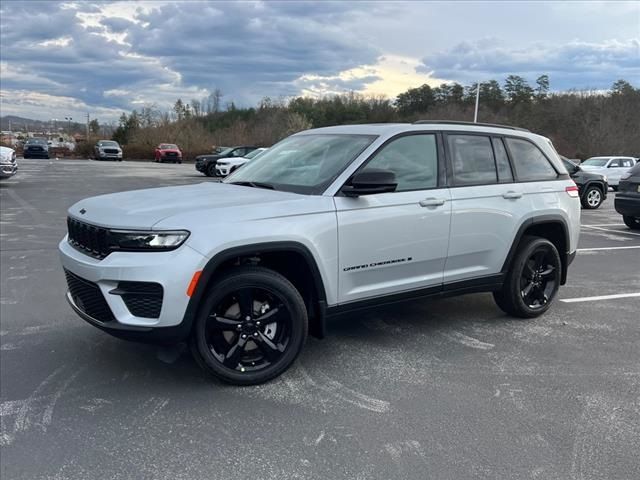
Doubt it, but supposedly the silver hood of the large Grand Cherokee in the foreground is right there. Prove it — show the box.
[68,182,330,229]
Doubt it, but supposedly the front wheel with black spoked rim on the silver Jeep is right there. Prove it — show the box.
[191,267,308,385]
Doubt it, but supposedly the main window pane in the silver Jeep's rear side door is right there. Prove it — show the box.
[447,135,498,185]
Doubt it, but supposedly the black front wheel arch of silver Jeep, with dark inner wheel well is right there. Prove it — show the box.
[182,241,327,338]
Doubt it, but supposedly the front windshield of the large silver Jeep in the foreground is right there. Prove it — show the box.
[225,134,376,194]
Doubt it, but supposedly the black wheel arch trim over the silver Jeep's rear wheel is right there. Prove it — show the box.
[501,215,572,285]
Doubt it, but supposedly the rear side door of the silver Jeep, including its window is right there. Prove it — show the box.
[444,132,531,284]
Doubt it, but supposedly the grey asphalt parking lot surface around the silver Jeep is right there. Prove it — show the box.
[0,160,640,480]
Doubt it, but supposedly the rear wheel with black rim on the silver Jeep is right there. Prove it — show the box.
[493,236,562,318]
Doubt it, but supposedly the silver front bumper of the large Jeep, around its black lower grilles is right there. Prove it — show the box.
[59,236,206,340]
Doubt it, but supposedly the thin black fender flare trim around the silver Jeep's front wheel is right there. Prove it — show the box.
[180,241,327,338]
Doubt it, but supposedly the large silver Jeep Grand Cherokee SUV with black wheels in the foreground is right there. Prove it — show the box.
[60,122,580,384]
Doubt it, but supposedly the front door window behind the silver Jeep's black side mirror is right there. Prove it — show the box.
[362,134,438,192]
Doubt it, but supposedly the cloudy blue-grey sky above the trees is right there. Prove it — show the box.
[0,0,640,122]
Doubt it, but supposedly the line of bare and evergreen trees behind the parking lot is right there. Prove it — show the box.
[110,75,640,159]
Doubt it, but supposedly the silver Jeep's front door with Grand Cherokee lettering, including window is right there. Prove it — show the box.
[335,133,451,303]
